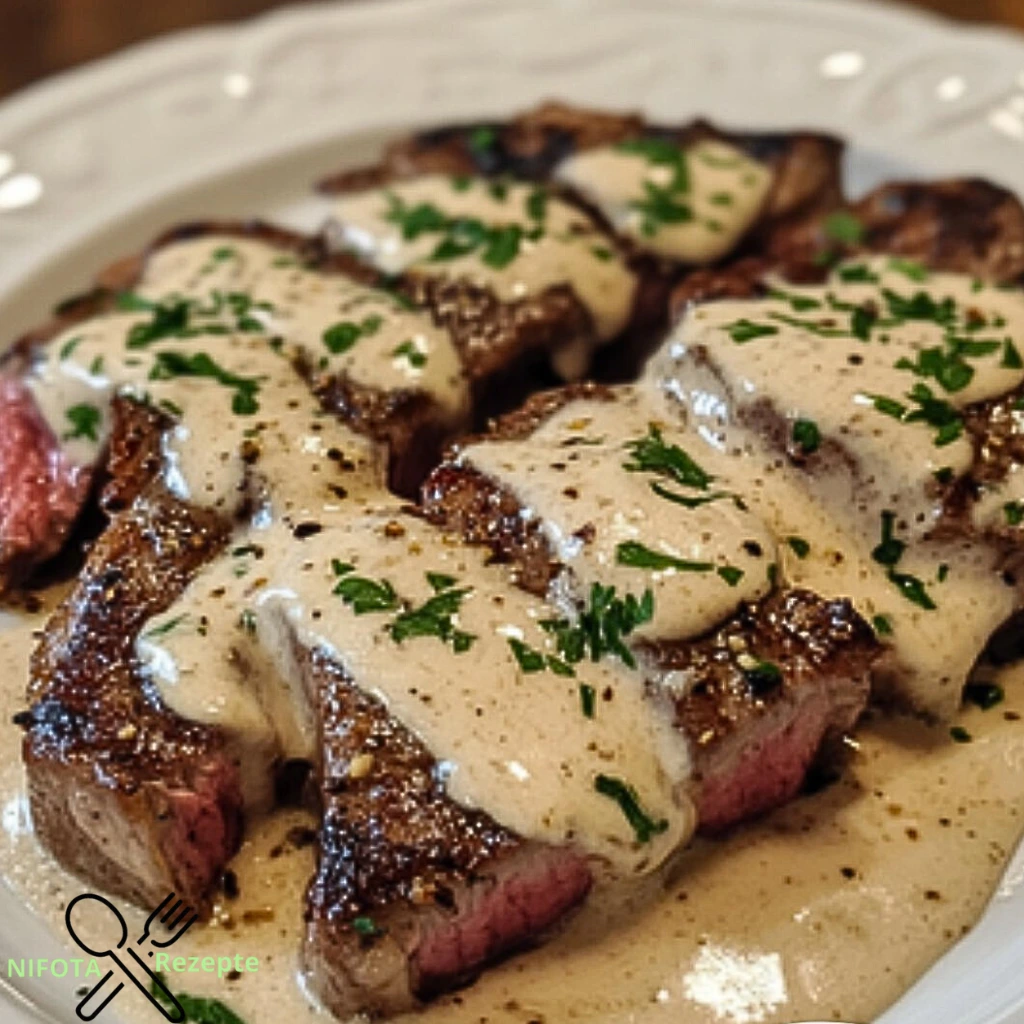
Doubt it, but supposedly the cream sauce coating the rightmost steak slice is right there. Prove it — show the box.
[648,259,1024,718]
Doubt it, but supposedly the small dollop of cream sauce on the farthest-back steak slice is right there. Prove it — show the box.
[555,139,772,264]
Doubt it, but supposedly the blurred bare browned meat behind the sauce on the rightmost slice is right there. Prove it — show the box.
[769,178,1024,284]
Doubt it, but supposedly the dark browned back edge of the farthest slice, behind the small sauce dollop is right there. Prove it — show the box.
[321,102,843,262]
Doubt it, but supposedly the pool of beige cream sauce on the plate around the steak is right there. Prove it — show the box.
[0,594,1024,1024]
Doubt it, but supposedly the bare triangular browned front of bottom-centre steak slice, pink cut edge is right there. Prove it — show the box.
[300,651,591,1017]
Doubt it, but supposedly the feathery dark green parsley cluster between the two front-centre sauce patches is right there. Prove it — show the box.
[539,583,654,669]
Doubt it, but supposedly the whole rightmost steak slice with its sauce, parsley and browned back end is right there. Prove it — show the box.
[652,199,1024,718]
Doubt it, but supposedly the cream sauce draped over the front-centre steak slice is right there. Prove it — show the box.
[142,510,694,872]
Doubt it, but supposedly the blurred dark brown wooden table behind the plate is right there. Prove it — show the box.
[0,0,1024,96]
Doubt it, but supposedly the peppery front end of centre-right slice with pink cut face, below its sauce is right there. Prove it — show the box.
[640,590,881,833]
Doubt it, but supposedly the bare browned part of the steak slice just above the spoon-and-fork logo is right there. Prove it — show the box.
[22,488,242,906]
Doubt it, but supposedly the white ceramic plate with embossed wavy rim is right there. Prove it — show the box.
[0,0,1024,1024]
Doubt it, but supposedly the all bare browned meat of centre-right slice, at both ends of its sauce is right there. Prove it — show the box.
[422,384,880,831]
